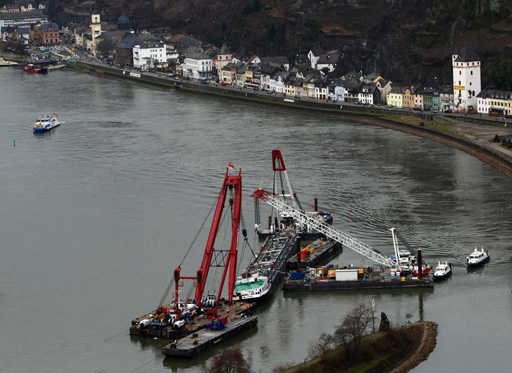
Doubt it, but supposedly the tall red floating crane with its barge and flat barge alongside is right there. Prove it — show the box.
[130,165,258,356]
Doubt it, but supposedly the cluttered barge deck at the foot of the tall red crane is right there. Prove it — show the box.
[130,301,255,339]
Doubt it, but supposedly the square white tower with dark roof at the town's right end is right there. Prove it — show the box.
[452,43,482,112]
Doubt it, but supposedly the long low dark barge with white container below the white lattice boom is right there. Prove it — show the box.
[282,265,434,291]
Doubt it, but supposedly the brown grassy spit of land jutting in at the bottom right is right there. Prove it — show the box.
[281,322,437,373]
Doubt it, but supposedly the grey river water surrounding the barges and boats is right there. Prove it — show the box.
[0,68,512,372]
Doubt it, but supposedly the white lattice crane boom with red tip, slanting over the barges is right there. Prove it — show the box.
[251,189,395,266]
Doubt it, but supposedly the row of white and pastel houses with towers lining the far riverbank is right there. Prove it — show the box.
[0,9,512,116]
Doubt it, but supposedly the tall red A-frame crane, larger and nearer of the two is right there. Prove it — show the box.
[174,165,246,305]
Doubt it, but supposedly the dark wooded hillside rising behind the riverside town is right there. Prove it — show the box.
[49,0,512,89]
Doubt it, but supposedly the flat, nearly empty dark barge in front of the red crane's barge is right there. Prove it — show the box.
[162,316,258,357]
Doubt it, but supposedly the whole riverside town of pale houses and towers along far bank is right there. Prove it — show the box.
[0,3,512,119]
